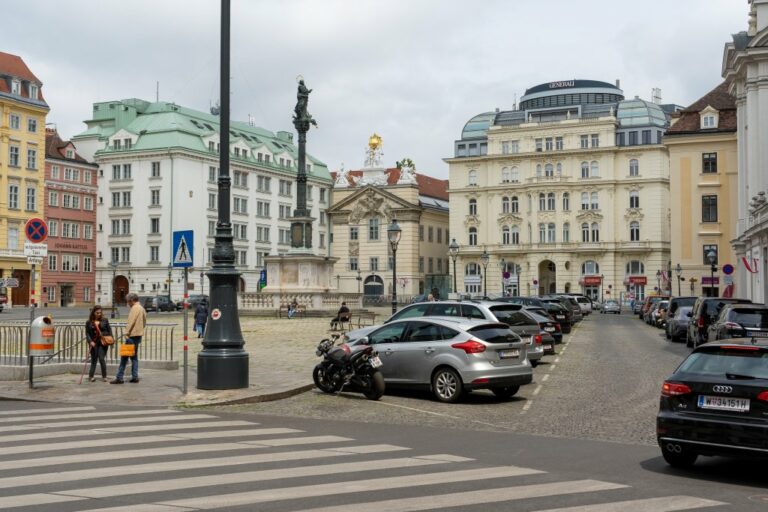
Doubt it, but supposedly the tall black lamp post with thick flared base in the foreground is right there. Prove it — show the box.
[197,0,249,389]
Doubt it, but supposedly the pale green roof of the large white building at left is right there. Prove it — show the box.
[72,98,331,181]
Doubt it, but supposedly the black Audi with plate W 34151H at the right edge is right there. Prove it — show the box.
[656,338,768,467]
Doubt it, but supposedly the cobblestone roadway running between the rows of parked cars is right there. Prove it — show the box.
[214,314,688,444]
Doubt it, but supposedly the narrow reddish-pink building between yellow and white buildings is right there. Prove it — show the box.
[40,128,99,307]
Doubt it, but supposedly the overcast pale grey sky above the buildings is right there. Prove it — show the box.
[6,0,748,177]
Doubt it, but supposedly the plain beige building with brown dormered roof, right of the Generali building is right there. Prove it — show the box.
[664,83,741,296]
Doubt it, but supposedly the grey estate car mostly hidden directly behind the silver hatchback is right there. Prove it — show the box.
[384,300,544,367]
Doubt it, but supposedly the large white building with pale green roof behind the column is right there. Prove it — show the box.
[73,99,332,304]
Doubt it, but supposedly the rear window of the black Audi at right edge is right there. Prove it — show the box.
[677,345,768,379]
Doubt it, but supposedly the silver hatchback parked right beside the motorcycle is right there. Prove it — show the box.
[347,317,533,403]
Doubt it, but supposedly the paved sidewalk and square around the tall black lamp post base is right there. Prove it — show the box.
[0,308,389,407]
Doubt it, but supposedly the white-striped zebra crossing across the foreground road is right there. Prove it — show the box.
[0,404,727,512]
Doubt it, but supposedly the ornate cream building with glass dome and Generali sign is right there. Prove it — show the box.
[446,80,674,299]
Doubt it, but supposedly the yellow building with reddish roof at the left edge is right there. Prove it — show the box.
[0,52,49,306]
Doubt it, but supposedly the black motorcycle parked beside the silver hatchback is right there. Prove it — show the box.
[312,336,384,400]
